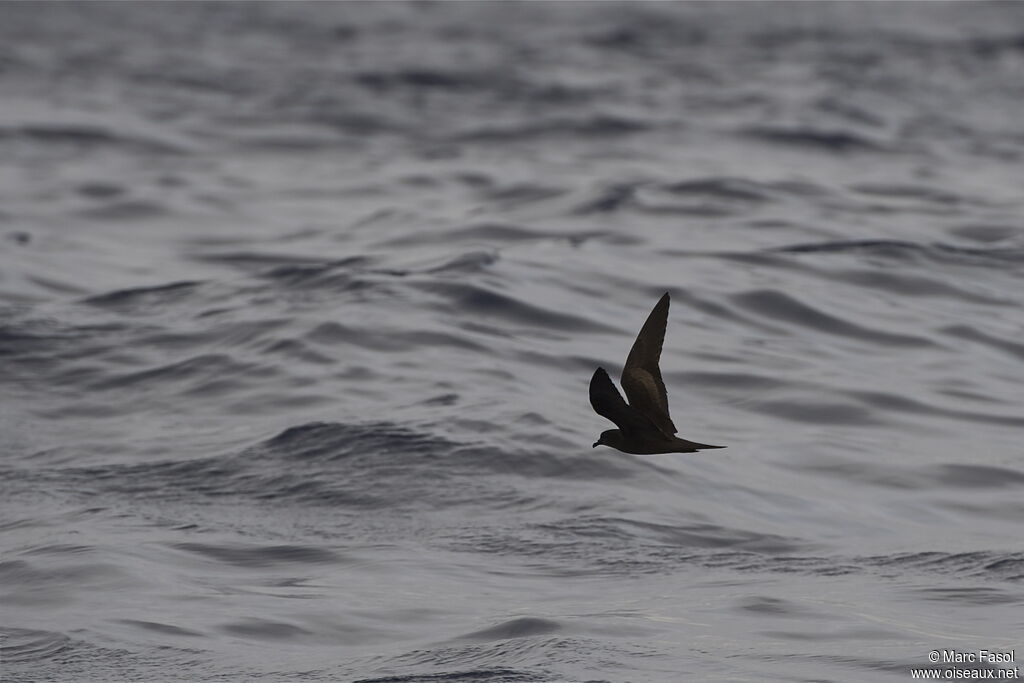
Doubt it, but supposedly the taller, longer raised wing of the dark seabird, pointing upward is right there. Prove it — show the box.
[622,292,677,436]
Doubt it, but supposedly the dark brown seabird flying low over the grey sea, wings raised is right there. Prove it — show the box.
[590,292,725,456]
